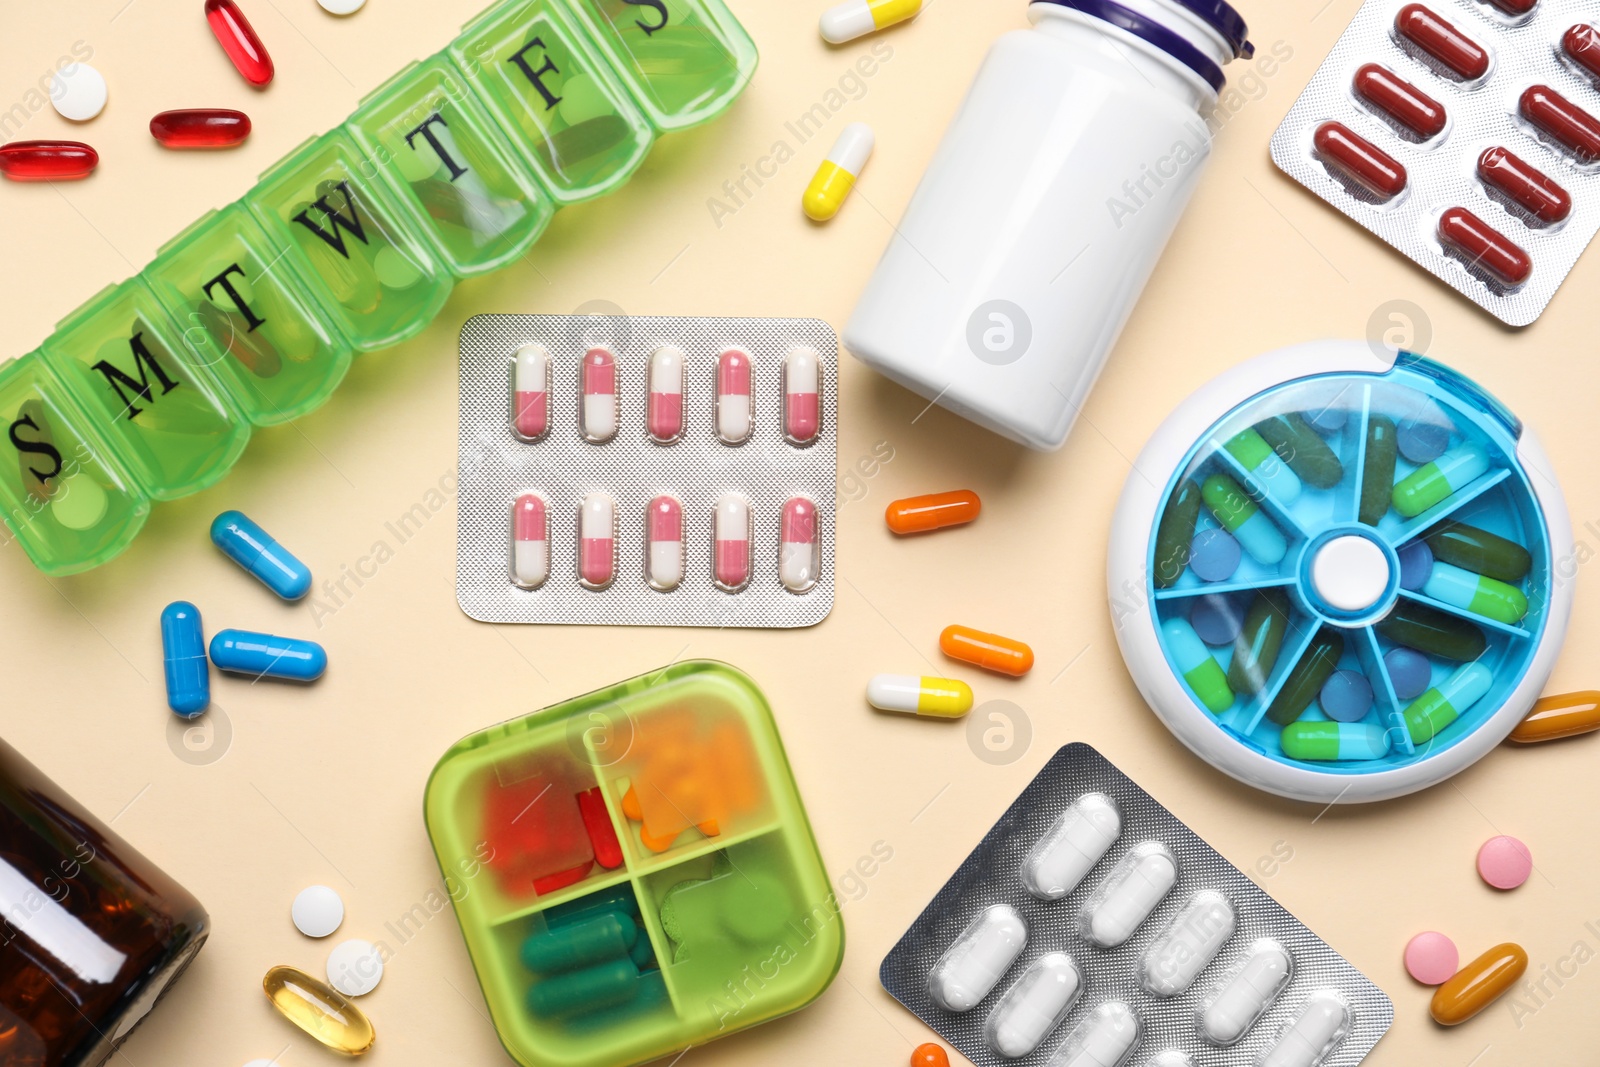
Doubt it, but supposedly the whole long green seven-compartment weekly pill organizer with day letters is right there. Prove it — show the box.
[0,0,757,576]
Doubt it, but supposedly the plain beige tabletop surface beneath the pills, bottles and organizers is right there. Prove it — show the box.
[0,0,1600,1067]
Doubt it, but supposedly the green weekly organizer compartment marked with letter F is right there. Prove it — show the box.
[450,0,656,206]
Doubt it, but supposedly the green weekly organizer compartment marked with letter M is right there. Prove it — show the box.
[42,277,250,501]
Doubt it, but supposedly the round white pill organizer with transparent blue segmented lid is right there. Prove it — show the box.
[1107,341,1573,803]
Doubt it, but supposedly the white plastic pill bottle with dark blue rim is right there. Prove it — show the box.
[845,0,1254,451]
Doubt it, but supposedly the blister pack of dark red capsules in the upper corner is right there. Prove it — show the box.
[1272,0,1600,326]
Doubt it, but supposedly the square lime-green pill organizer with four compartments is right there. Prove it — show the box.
[424,661,845,1067]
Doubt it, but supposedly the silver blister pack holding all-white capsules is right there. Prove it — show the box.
[880,744,1394,1067]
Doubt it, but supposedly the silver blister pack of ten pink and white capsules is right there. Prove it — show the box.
[456,315,838,629]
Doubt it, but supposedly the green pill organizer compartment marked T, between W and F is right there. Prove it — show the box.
[346,56,555,277]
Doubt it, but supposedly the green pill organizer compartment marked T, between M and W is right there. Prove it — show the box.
[139,203,350,426]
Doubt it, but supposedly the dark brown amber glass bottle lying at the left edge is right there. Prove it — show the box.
[0,741,210,1067]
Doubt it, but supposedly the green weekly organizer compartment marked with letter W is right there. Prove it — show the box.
[243,130,454,352]
